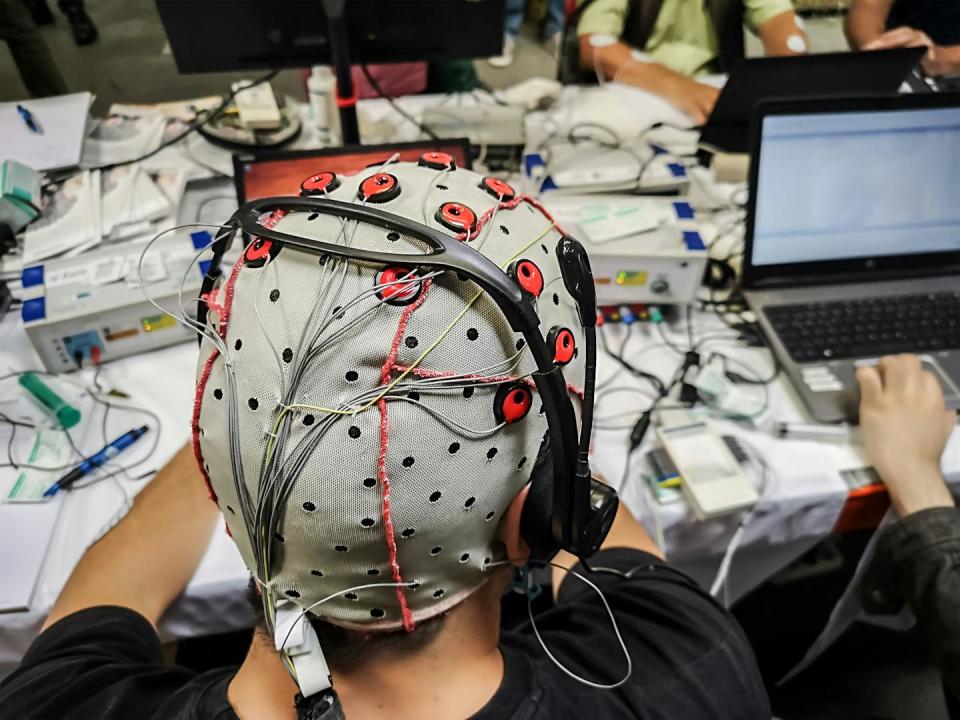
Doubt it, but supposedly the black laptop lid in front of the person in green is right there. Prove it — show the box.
[700,48,926,153]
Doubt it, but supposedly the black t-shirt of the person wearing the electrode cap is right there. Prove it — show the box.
[0,549,770,720]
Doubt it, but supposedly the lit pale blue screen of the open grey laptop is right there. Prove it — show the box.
[749,107,960,266]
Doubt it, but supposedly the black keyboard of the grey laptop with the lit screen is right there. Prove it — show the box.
[763,292,960,362]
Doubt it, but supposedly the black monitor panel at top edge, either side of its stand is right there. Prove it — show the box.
[156,0,505,73]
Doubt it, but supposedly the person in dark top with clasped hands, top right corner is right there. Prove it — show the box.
[843,0,960,75]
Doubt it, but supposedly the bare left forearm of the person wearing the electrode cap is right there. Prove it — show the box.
[44,446,220,627]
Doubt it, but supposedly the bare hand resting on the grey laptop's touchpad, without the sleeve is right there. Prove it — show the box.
[857,355,956,517]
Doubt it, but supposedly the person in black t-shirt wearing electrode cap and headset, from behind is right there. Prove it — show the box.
[0,159,769,718]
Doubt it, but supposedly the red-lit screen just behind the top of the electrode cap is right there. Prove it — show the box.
[234,139,471,203]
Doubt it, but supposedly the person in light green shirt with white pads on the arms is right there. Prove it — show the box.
[577,0,807,125]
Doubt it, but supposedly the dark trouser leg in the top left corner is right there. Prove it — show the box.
[0,0,67,97]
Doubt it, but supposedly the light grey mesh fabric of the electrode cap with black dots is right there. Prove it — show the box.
[194,163,583,630]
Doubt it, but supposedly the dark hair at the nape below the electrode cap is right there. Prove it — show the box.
[246,577,446,673]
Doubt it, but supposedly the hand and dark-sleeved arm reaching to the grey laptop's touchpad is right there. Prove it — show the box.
[857,355,960,704]
